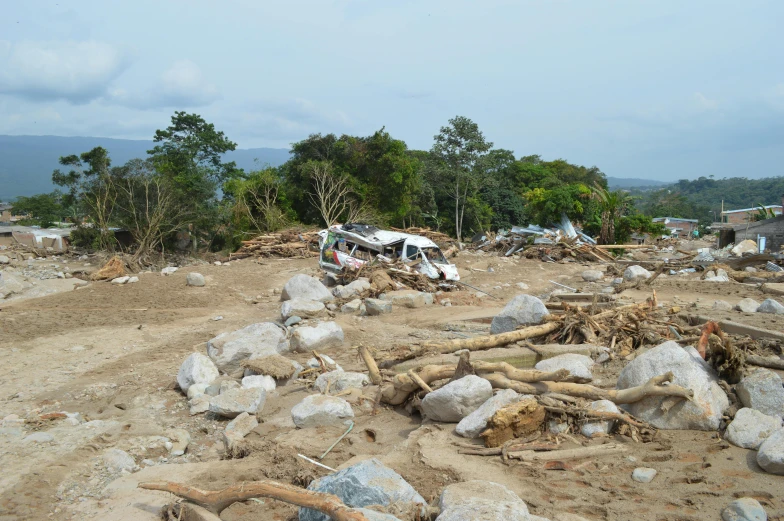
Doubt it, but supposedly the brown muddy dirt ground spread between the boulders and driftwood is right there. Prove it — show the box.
[0,249,784,521]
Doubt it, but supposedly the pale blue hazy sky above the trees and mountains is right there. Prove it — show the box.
[0,0,784,181]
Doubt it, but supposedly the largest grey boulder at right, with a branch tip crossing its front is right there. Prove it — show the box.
[616,341,729,430]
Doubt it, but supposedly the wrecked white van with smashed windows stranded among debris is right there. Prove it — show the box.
[319,224,460,280]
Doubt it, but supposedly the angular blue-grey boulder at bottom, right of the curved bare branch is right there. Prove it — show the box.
[299,458,427,521]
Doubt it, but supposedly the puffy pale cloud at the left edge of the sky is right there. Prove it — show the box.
[0,40,130,103]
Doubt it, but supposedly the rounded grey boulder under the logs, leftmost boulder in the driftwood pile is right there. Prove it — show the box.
[422,375,493,423]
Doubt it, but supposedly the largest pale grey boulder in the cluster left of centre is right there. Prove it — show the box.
[207,322,289,373]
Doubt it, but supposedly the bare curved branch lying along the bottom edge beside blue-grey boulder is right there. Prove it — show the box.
[138,481,368,521]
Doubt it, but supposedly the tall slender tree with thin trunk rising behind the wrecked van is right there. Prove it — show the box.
[430,116,493,241]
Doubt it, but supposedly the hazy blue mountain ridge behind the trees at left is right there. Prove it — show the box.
[0,135,289,201]
